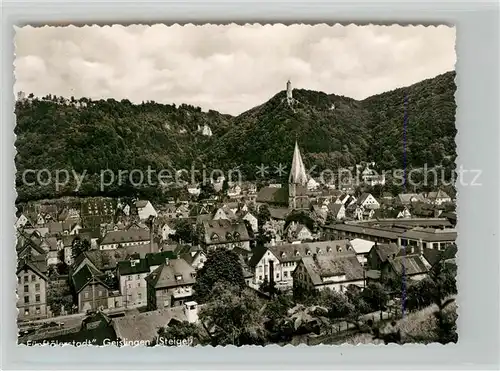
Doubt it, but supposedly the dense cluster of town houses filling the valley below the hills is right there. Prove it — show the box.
[15,146,456,332]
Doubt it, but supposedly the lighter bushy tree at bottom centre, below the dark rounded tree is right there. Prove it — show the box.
[199,282,267,346]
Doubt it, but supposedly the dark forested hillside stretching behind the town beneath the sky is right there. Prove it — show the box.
[15,72,456,201]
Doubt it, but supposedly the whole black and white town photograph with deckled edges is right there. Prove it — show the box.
[9,23,458,352]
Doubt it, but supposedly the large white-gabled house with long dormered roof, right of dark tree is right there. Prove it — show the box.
[248,240,352,290]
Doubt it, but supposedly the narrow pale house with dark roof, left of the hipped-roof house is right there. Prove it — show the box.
[116,254,151,308]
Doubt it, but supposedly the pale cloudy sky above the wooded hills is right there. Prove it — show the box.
[14,24,456,115]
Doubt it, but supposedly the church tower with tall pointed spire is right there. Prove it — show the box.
[288,142,309,210]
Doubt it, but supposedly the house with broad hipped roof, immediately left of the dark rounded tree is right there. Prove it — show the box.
[146,259,196,310]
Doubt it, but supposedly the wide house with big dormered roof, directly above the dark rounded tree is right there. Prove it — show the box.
[203,219,250,250]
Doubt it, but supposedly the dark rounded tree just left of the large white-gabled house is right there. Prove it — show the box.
[193,248,246,303]
